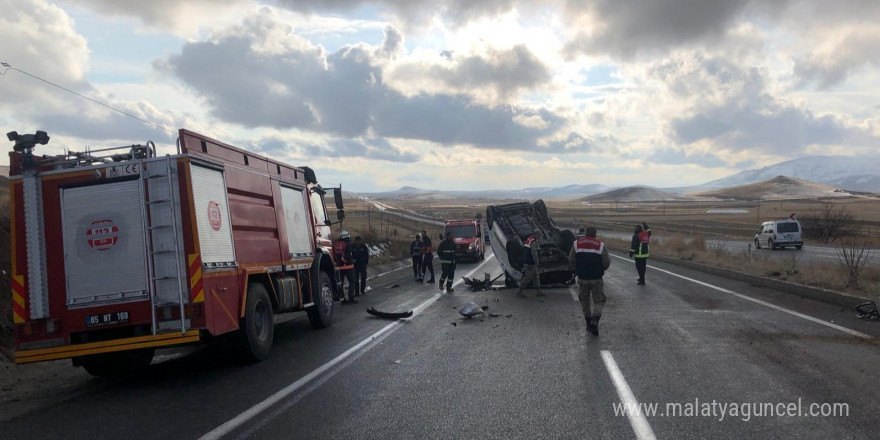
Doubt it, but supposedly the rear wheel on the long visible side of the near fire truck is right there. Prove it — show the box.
[236,283,275,362]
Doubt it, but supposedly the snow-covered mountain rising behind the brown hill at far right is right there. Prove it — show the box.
[687,154,880,193]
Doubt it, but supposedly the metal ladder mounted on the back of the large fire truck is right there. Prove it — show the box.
[140,155,187,335]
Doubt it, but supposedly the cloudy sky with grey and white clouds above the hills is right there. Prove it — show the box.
[0,0,880,191]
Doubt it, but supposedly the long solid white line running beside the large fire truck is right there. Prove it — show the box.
[200,254,495,440]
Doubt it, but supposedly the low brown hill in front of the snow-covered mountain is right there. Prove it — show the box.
[692,176,853,200]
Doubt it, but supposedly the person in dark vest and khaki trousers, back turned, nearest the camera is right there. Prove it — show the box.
[568,226,611,336]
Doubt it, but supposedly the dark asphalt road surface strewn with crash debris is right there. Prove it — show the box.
[0,251,880,439]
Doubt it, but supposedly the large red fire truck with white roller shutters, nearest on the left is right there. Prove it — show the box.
[8,129,344,375]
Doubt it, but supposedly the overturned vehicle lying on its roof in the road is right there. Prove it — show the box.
[486,200,575,287]
